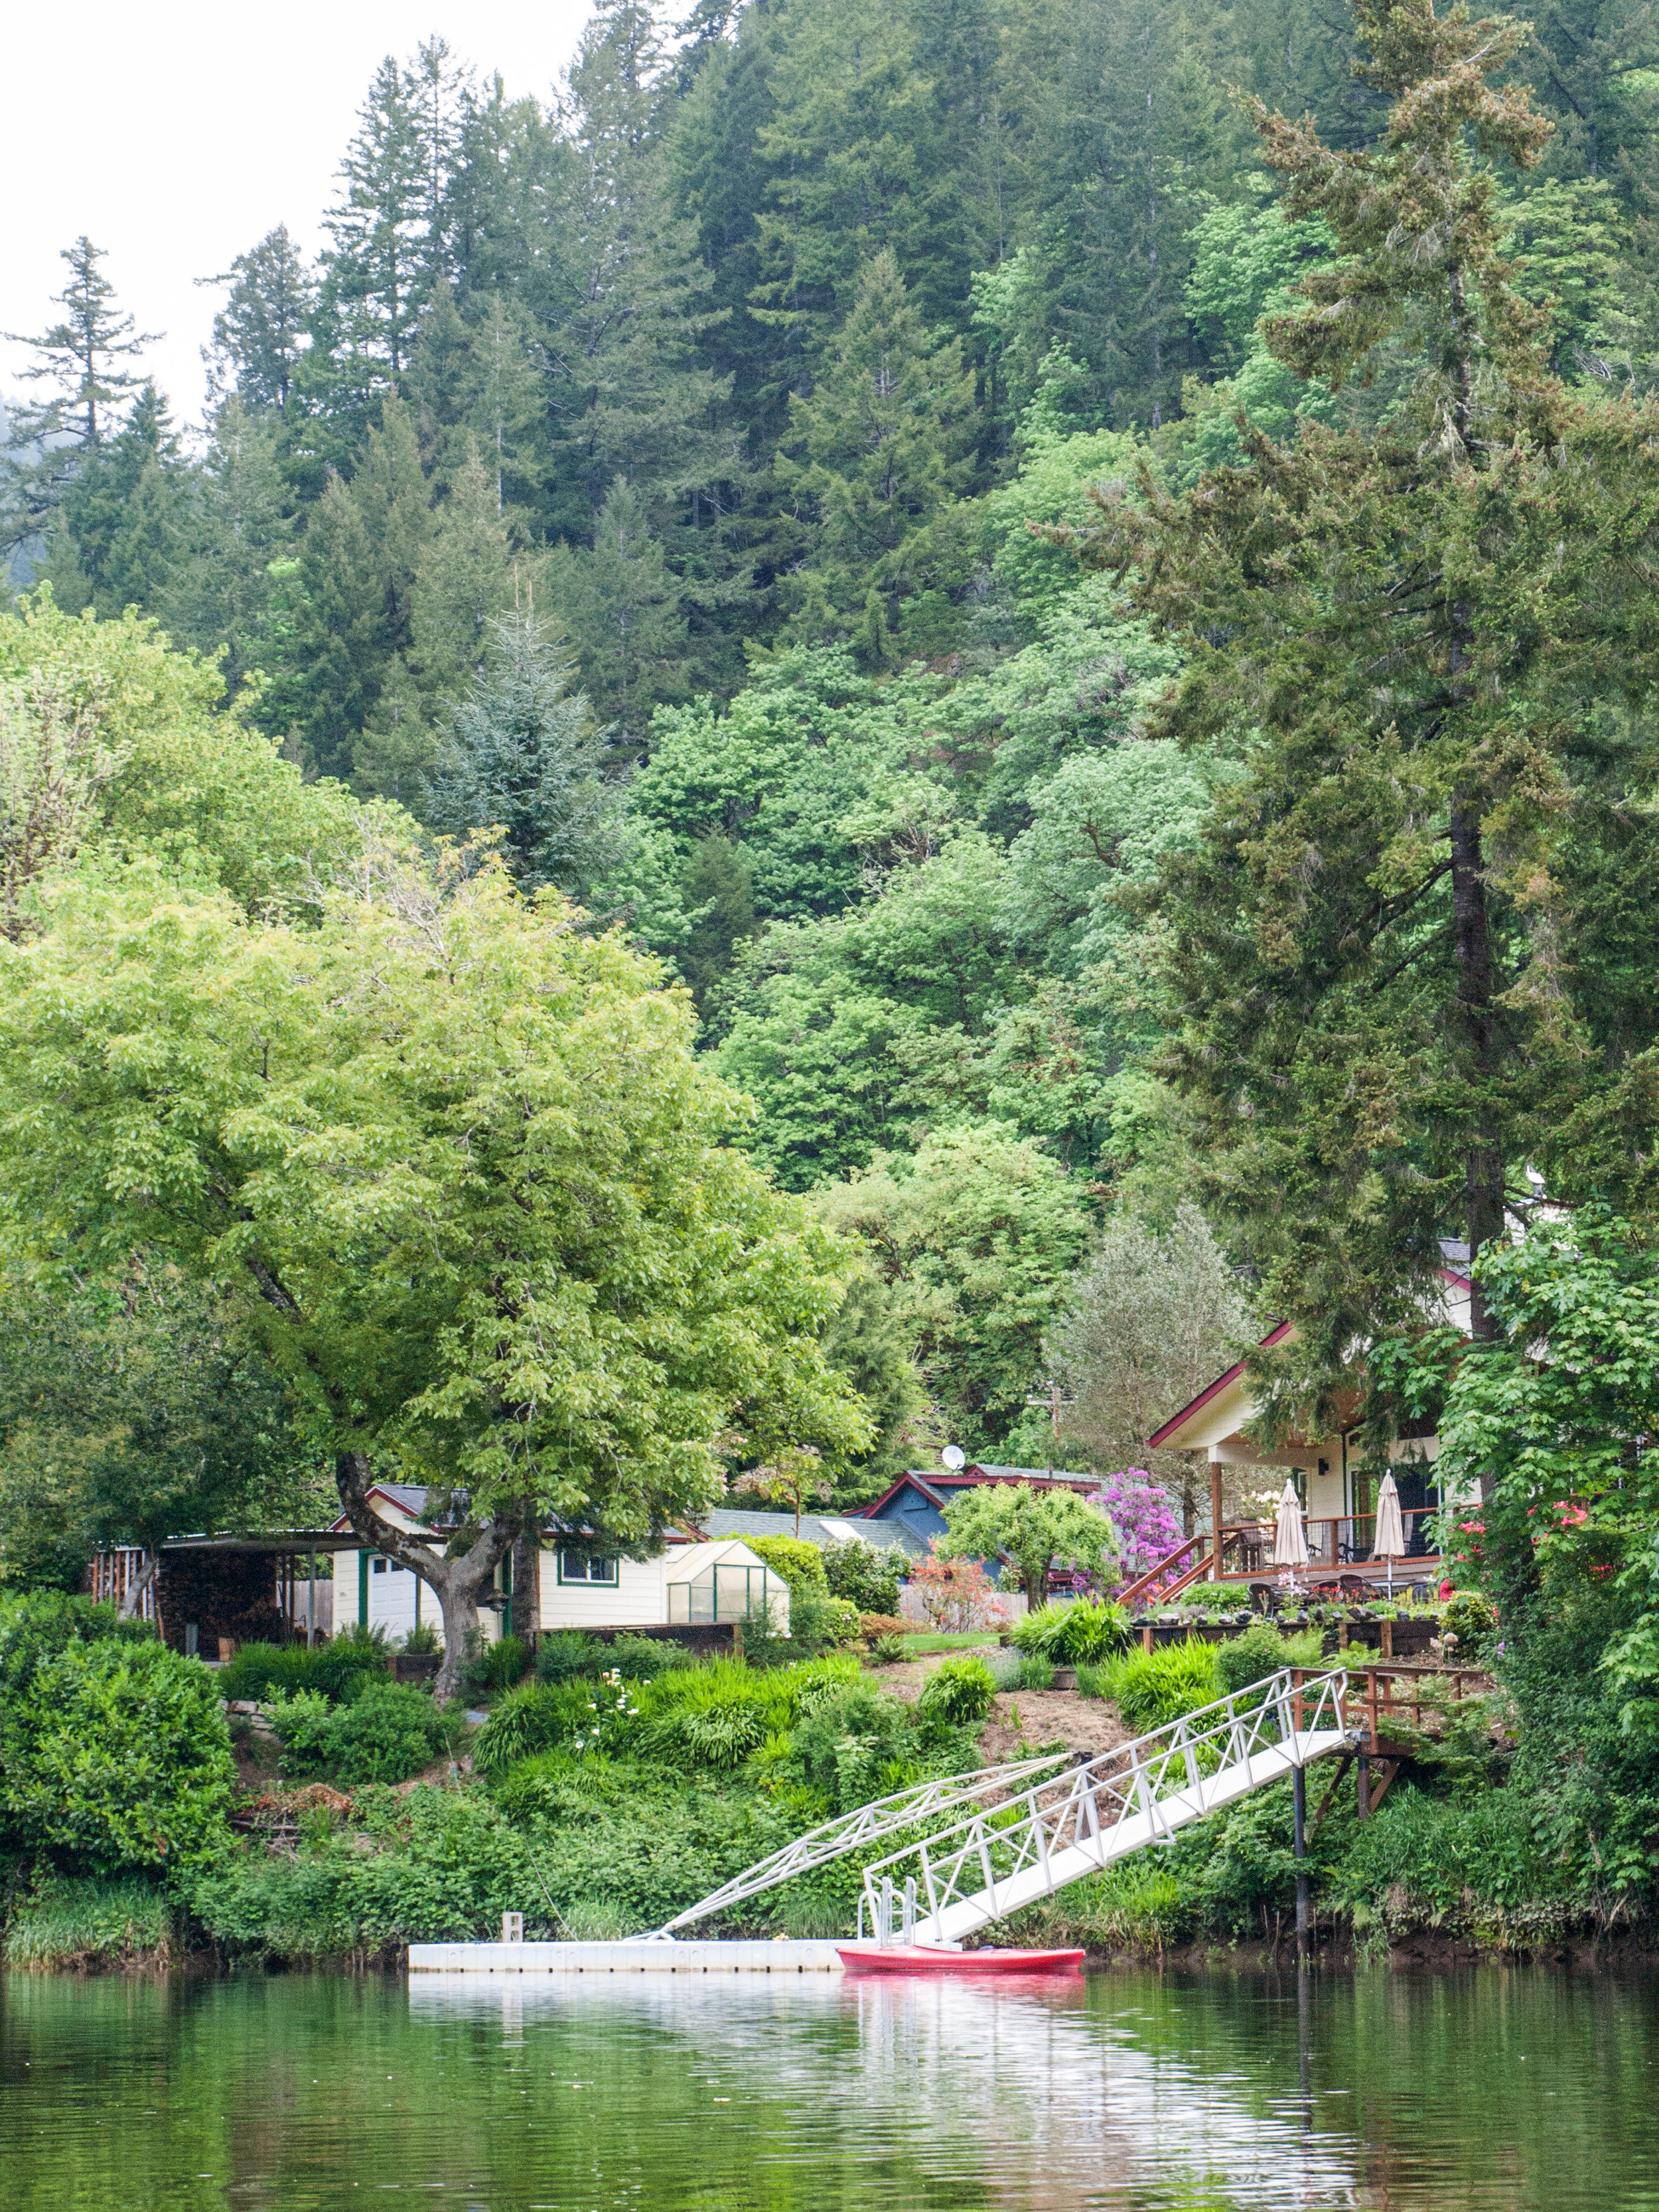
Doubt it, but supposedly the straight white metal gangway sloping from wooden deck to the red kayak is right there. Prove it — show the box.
[858,1668,1354,1947]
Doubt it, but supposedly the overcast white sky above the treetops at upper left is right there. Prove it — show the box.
[0,0,589,420]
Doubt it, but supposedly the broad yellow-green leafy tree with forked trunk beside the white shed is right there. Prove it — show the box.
[0,845,867,1694]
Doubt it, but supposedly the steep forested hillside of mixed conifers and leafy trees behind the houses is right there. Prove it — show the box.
[5,0,1659,1489]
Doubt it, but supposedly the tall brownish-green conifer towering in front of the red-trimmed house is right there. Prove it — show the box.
[1093,0,1659,1387]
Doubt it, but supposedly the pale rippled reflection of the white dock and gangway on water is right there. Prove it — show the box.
[409,1975,1360,2212]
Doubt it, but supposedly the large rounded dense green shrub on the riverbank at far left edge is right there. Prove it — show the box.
[0,1613,232,1874]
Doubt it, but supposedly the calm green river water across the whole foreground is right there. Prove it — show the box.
[0,1966,1659,2212]
